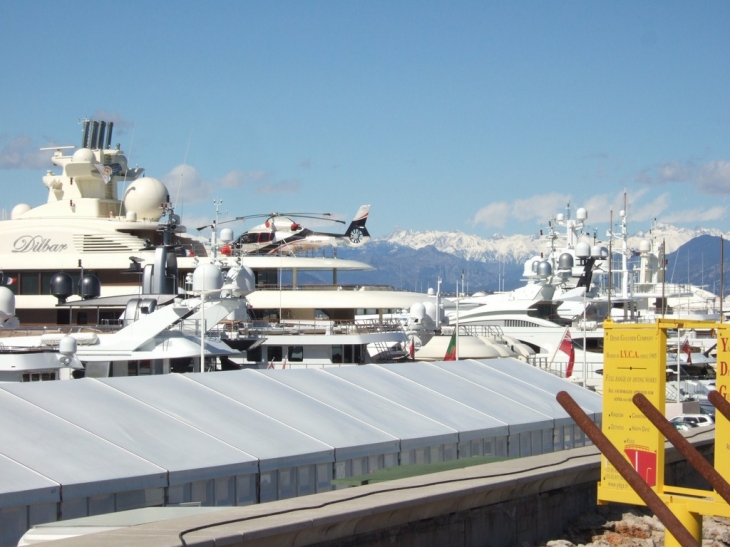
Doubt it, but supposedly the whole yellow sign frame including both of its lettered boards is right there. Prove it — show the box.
[598,319,730,546]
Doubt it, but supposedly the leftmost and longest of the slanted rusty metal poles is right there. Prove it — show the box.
[555,391,700,547]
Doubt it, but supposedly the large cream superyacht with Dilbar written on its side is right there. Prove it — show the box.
[0,120,416,326]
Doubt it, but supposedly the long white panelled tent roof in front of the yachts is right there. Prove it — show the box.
[0,359,602,507]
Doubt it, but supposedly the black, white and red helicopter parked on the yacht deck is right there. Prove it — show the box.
[203,205,370,255]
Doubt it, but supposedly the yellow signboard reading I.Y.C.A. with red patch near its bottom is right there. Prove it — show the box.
[598,321,667,504]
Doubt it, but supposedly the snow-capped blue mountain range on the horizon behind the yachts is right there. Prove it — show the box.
[301,224,730,293]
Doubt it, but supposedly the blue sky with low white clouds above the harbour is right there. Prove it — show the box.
[0,0,730,237]
